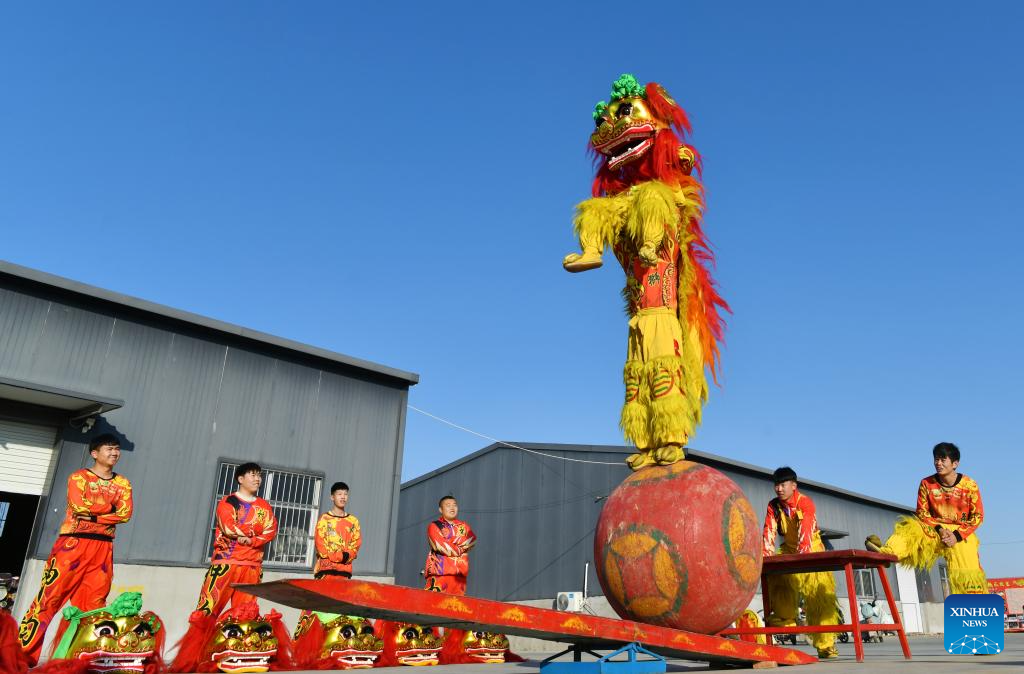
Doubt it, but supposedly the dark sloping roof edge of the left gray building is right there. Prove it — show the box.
[0,260,420,385]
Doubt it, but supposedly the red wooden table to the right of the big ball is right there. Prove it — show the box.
[722,550,910,663]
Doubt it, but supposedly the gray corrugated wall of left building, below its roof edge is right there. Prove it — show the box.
[0,278,408,575]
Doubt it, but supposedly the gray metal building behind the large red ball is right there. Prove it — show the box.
[395,443,944,631]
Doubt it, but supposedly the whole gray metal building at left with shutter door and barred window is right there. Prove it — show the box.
[0,261,418,636]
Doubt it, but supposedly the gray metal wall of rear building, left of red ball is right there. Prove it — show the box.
[395,449,628,600]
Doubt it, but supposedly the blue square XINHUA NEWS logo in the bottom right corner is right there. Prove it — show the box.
[942,594,1005,656]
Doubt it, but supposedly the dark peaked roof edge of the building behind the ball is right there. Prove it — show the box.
[401,441,914,512]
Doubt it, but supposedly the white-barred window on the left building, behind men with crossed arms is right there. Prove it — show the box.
[206,461,324,568]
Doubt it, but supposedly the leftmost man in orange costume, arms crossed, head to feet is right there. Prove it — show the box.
[18,434,132,666]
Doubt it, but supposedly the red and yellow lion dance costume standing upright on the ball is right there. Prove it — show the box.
[562,70,729,470]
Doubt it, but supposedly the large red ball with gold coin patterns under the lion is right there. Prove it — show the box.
[594,461,761,634]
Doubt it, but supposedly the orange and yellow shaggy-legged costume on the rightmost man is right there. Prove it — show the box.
[882,473,988,594]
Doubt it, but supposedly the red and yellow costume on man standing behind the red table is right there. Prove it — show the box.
[764,491,839,655]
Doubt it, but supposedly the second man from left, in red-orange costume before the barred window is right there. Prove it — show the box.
[196,463,278,616]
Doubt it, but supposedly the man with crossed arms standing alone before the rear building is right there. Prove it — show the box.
[423,495,476,595]
